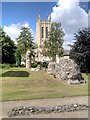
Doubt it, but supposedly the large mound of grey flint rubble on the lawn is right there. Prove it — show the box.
[48,57,85,84]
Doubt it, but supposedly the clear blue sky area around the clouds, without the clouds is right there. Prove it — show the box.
[2,2,88,31]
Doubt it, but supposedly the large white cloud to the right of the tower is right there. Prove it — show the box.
[51,0,88,48]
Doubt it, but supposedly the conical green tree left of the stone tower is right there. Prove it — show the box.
[17,27,36,66]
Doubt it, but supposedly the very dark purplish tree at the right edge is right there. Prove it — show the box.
[70,28,90,72]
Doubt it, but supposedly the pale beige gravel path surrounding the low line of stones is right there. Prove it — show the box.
[2,96,88,118]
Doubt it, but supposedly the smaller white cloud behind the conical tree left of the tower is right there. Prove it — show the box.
[4,22,34,43]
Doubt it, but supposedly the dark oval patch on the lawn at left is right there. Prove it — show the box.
[1,71,29,77]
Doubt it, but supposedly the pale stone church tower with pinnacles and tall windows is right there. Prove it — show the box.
[36,15,51,62]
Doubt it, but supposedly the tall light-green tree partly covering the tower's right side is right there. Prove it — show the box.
[43,23,64,61]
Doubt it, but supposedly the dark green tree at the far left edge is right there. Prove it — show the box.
[0,28,16,64]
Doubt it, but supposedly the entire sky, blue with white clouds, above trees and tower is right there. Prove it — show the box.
[2,0,89,49]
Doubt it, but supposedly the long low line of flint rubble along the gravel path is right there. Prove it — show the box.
[7,104,90,117]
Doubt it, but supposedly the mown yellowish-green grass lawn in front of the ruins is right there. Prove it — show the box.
[1,68,88,101]
